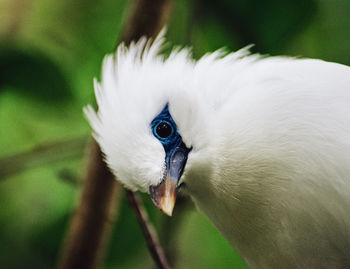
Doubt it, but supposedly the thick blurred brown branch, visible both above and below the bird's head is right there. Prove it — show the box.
[58,0,172,269]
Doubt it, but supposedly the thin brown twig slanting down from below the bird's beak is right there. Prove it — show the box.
[126,190,170,269]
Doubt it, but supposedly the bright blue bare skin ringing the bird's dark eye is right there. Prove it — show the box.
[151,104,183,156]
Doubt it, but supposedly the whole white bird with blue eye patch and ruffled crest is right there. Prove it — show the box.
[85,31,350,269]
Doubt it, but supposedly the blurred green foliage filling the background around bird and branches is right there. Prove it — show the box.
[0,0,350,268]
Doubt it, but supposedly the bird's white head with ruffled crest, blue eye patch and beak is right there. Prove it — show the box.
[85,32,213,215]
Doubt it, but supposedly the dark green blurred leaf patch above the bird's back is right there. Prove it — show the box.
[189,0,317,53]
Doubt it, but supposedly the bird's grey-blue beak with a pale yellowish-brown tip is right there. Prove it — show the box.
[150,143,190,216]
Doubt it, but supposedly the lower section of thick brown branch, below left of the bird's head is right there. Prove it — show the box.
[58,141,121,269]
